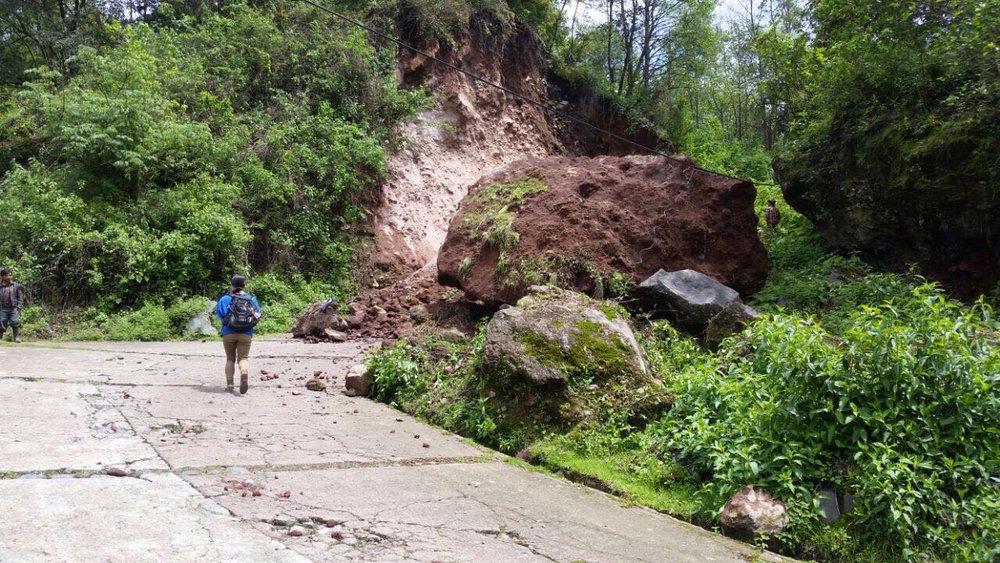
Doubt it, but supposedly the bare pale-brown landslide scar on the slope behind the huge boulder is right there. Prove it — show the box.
[374,28,561,279]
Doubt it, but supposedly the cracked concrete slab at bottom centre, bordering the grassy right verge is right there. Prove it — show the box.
[188,463,747,562]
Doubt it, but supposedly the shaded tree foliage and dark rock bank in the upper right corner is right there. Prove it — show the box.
[777,1,1000,298]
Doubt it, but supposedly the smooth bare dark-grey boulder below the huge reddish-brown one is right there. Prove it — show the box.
[639,270,756,337]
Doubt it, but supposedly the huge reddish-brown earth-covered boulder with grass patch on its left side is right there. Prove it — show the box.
[437,156,767,304]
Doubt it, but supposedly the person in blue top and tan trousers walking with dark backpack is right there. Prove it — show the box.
[215,274,260,395]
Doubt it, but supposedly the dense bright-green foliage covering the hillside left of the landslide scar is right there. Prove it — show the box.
[0,4,426,329]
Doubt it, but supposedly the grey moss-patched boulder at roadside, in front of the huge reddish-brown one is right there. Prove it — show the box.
[484,287,647,383]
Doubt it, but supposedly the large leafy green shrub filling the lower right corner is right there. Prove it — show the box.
[659,286,1000,560]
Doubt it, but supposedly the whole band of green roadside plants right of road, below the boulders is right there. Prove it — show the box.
[369,193,1000,562]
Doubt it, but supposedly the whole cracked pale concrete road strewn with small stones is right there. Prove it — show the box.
[0,338,772,562]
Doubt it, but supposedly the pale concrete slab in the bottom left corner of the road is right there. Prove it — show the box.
[0,474,308,563]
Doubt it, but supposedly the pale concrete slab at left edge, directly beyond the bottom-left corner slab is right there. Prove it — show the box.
[0,379,167,472]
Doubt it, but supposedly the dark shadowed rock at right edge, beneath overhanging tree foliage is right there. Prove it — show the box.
[774,121,1000,299]
